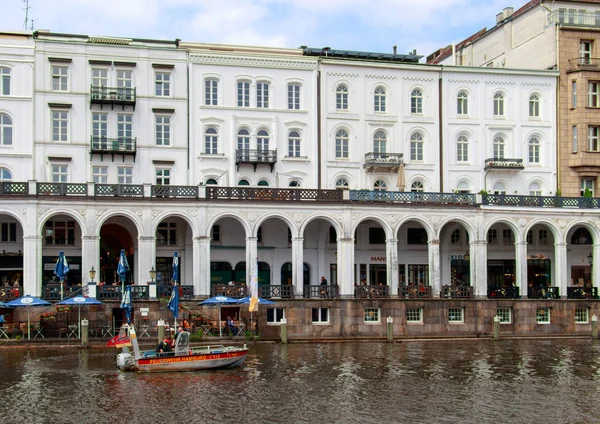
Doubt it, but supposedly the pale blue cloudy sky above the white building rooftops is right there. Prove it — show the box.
[0,0,527,55]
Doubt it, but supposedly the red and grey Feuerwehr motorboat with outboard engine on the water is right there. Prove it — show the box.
[113,324,248,372]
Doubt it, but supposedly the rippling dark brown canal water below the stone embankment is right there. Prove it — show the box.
[0,339,600,424]
